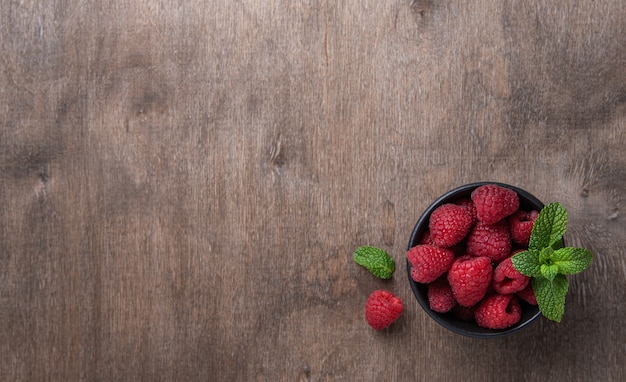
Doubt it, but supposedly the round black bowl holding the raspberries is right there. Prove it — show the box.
[406,182,544,338]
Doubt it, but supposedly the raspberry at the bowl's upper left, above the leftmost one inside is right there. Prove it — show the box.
[428,203,472,247]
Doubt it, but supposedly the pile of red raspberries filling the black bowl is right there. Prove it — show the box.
[406,184,539,329]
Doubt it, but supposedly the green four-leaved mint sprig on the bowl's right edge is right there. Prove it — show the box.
[511,203,593,322]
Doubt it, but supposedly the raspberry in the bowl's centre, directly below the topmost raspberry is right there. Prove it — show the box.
[466,220,512,262]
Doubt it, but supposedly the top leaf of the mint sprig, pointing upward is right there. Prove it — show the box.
[528,203,567,250]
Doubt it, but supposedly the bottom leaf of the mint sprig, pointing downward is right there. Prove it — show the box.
[532,274,569,322]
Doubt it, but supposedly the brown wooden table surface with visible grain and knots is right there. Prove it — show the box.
[0,0,626,381]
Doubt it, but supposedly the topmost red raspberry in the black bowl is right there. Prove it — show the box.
[471,184,519,224]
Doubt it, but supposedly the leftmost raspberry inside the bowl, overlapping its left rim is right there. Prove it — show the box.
[406,245,454,284]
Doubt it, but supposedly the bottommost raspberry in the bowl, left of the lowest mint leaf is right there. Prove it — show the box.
[474,294,522,329]
